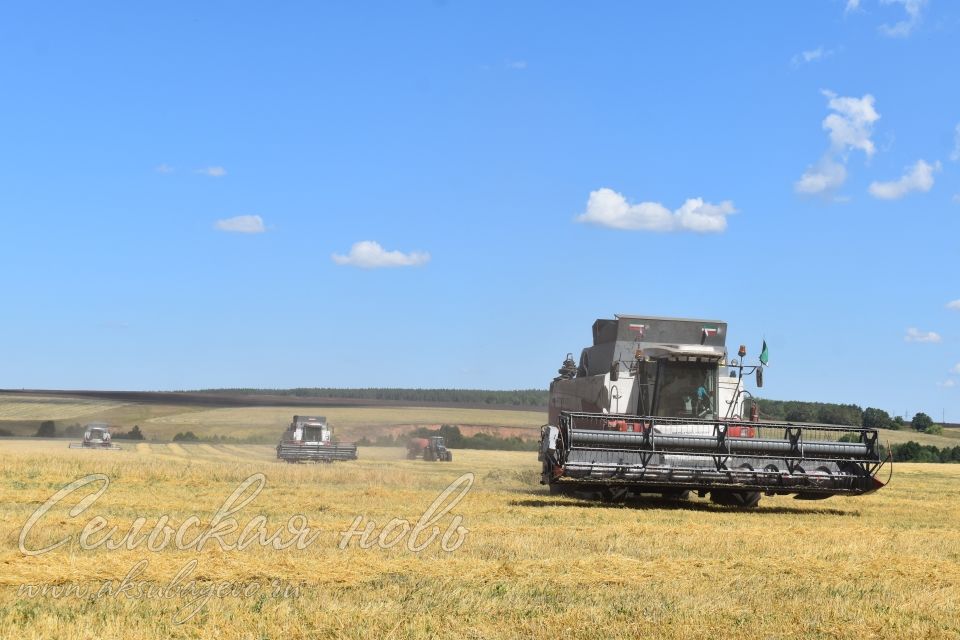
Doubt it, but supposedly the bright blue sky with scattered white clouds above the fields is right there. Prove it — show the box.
[0,0,960,421]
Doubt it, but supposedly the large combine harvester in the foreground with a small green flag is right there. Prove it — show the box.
[540,315,889,507]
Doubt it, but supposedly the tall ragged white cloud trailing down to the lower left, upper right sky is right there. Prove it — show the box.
[793,90,880,195]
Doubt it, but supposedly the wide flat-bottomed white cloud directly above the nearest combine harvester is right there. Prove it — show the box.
[575,188,736,233]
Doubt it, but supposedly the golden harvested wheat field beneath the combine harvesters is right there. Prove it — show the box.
[0,441,960,640]
